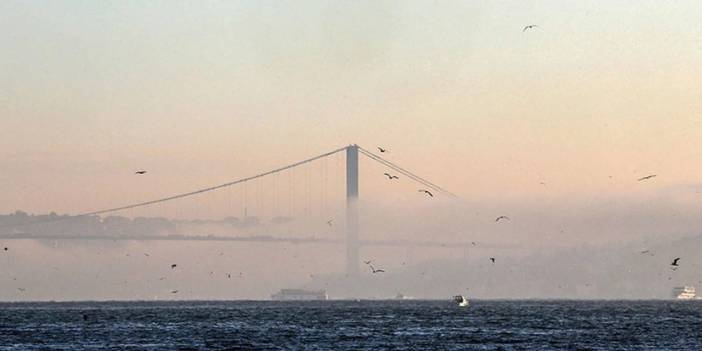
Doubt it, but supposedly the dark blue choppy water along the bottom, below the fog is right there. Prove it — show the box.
[0,301,702,350]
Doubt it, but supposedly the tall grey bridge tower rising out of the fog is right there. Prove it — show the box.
[346,144,359,278]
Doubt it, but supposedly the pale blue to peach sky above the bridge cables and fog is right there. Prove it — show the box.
[0,0,702,300]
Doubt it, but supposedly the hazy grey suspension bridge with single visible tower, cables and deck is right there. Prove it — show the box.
[0,144,511,276]
